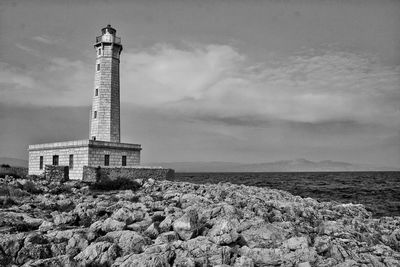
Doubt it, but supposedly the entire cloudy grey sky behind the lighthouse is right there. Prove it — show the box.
[0,0,400,166]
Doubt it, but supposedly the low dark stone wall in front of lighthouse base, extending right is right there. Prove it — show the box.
[82,166,175,183]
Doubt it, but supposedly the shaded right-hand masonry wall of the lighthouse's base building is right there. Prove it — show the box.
[87,147,140,167]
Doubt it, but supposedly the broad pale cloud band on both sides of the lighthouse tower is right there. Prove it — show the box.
[0,44,400,128]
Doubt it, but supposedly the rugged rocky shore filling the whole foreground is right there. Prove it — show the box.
[0,177,400,267]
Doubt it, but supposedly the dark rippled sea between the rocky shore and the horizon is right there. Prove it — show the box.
[171,172,400,217]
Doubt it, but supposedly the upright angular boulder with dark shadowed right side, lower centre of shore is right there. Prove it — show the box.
[173,210,201,240]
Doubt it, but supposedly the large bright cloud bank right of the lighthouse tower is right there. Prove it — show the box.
[122,45,400,129]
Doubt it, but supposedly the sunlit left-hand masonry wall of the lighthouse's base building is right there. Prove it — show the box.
[29,146,89,179]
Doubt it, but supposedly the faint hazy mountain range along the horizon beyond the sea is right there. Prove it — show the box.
[148,159,400,172]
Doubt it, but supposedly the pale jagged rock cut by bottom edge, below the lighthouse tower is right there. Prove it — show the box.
[74,241,118,266]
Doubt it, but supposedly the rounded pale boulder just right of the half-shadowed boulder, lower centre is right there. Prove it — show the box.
[208,219,239,245]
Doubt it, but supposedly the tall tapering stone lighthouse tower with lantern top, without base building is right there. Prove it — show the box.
[89,25,122,143]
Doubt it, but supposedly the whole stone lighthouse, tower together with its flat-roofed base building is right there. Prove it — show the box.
[28,25,141,179]
